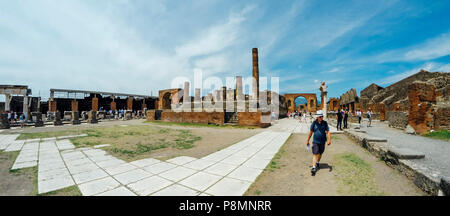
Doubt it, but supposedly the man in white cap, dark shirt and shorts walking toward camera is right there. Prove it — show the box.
[306,110,331,176]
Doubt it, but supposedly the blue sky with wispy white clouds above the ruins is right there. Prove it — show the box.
[0,0,450,100]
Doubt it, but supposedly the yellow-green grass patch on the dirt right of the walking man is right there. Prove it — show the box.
[334,153,385,196]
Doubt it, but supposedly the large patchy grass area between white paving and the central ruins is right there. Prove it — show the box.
[21,125,201,161]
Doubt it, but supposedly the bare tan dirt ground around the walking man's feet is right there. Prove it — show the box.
[246,134,425,196]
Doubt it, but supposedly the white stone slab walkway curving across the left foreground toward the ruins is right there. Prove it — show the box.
[0,127,290,196]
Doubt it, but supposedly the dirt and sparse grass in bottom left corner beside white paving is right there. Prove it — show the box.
[0,152,34,196]
